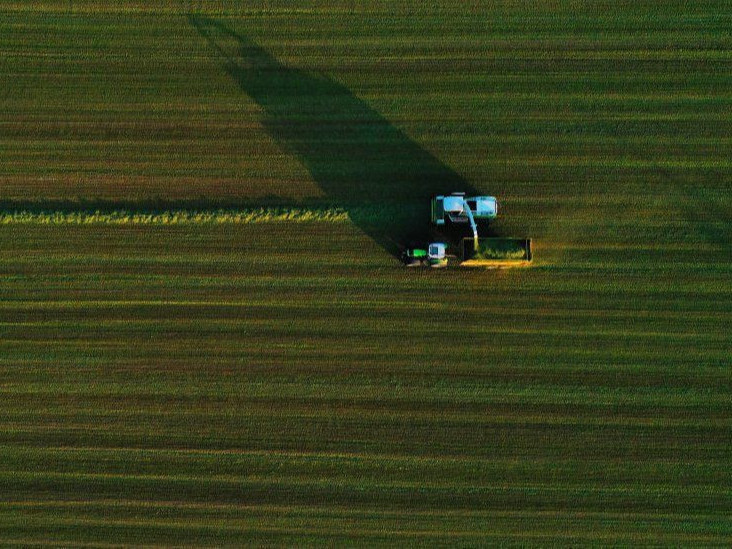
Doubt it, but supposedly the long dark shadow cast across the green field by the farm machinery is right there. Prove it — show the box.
[188,15,486,255]
